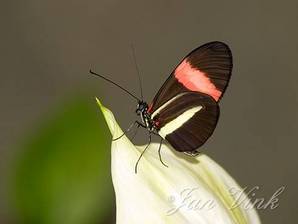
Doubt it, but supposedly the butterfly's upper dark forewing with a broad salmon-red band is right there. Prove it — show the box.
[148,41,232,113]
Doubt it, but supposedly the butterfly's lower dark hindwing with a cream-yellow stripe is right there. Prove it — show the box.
[151,92,219,152]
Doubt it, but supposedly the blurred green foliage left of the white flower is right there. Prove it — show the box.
[11,97,114,224]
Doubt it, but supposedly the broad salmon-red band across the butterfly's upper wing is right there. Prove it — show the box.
[174,59,222,101]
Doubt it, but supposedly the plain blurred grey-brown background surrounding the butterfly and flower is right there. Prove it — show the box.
[0,0,298,224]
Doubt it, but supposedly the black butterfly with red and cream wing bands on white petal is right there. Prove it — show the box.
[90,41,233,172]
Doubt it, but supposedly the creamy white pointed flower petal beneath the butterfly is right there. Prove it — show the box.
[97,100,260,224]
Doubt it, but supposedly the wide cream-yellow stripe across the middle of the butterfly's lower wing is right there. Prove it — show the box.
[158,106,203,138]
